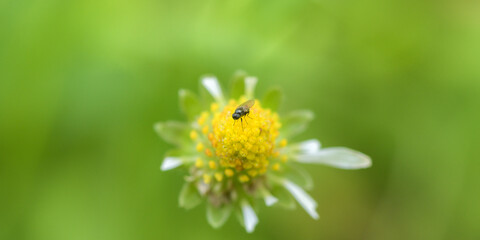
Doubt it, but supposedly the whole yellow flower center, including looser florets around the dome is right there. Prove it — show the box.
[190,98,287,184]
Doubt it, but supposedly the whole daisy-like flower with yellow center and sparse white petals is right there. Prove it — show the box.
[154,73,371,233]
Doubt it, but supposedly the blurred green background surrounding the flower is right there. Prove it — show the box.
[0,0,480,240]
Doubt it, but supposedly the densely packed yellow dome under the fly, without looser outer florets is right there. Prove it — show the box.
[209,100,280,176]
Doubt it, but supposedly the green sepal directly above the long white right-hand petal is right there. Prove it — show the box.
[280,110,315,138]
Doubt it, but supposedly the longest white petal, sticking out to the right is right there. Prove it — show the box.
[295,147,372,169]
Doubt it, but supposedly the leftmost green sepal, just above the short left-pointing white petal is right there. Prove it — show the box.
[154,121,190,146]
